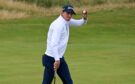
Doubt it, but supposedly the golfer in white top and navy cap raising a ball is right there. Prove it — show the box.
[42,5,87,84]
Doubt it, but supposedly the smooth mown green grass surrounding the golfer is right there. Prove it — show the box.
[0,9,135,84]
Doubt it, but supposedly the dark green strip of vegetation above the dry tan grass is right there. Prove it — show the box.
[14,0,135,7]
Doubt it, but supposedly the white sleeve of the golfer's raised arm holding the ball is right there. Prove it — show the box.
[69,18,87,26]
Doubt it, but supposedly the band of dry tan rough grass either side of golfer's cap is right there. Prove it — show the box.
[0,0,135,19]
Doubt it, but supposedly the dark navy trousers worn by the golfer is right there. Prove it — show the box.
[42,55,73,84]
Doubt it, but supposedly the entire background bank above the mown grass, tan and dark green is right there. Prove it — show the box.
[0,0,135,19]
